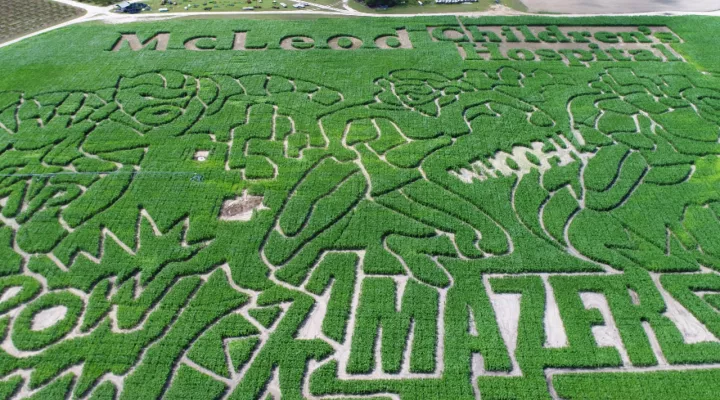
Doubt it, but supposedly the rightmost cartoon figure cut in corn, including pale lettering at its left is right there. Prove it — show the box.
[444,68,720,271]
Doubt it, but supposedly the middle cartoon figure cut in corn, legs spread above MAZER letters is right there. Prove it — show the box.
[264,68,557,287]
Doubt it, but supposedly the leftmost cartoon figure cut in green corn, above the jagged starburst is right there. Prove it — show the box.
[0,71,342,258]
